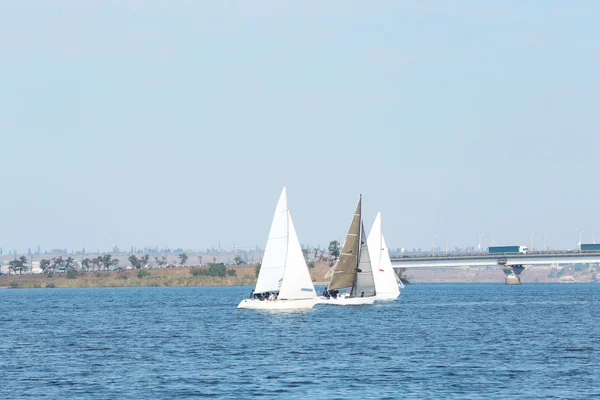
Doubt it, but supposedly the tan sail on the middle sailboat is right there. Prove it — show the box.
[328,196,362,290]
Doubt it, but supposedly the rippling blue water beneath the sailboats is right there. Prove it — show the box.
[0,284,600,399]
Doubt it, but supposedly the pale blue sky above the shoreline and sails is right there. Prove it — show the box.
[0,0,600,253]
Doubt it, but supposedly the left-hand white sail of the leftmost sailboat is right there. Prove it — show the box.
[254,187,289,293]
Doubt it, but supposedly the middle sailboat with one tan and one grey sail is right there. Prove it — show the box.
[319,195,377,306]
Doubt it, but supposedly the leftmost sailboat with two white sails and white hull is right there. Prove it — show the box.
[238,187,317,310]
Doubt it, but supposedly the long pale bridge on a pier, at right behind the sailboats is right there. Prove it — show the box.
[392,251,600,285]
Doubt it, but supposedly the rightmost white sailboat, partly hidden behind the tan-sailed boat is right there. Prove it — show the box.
[367,212,404,300]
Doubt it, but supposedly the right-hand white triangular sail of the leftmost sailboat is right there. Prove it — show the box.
[278,210,317,300]
